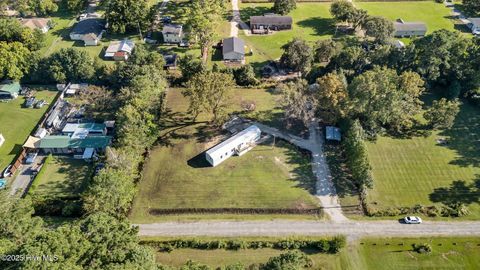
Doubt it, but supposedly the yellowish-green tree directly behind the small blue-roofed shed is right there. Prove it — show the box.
[315,73,348,123]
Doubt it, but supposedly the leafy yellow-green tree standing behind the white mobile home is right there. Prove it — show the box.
[183,71,235,124]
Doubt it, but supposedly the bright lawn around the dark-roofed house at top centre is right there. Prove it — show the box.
[239,3,335,63]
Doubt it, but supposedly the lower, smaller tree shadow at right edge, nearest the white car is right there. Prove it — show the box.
[429,175,480,206]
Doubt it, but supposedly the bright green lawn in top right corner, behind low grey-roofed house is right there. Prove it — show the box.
[355,1,455,33]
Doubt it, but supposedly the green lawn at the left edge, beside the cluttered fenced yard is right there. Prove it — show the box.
[0,88,58,170]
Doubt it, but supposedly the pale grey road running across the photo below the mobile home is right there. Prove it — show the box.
[139,220,480,239]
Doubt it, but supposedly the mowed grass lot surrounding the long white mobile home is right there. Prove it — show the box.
[130,89,318,222]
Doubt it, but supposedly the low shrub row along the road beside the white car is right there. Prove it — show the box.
[364,204,469,217]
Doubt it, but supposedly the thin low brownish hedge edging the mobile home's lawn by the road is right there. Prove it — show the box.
[149,208,323,216]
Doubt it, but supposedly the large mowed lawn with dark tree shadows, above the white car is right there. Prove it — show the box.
[368,100,480,219]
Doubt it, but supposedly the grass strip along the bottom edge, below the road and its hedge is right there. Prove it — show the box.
[152,237,480,270]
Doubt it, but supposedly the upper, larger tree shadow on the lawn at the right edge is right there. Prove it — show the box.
[439,102,480,167]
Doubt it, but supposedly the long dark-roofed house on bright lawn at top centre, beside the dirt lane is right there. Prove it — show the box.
[250,13,293,34]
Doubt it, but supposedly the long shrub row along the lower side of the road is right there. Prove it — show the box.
[140,236,346,254]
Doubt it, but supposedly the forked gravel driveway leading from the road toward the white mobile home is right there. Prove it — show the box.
[253,121,348,222]
